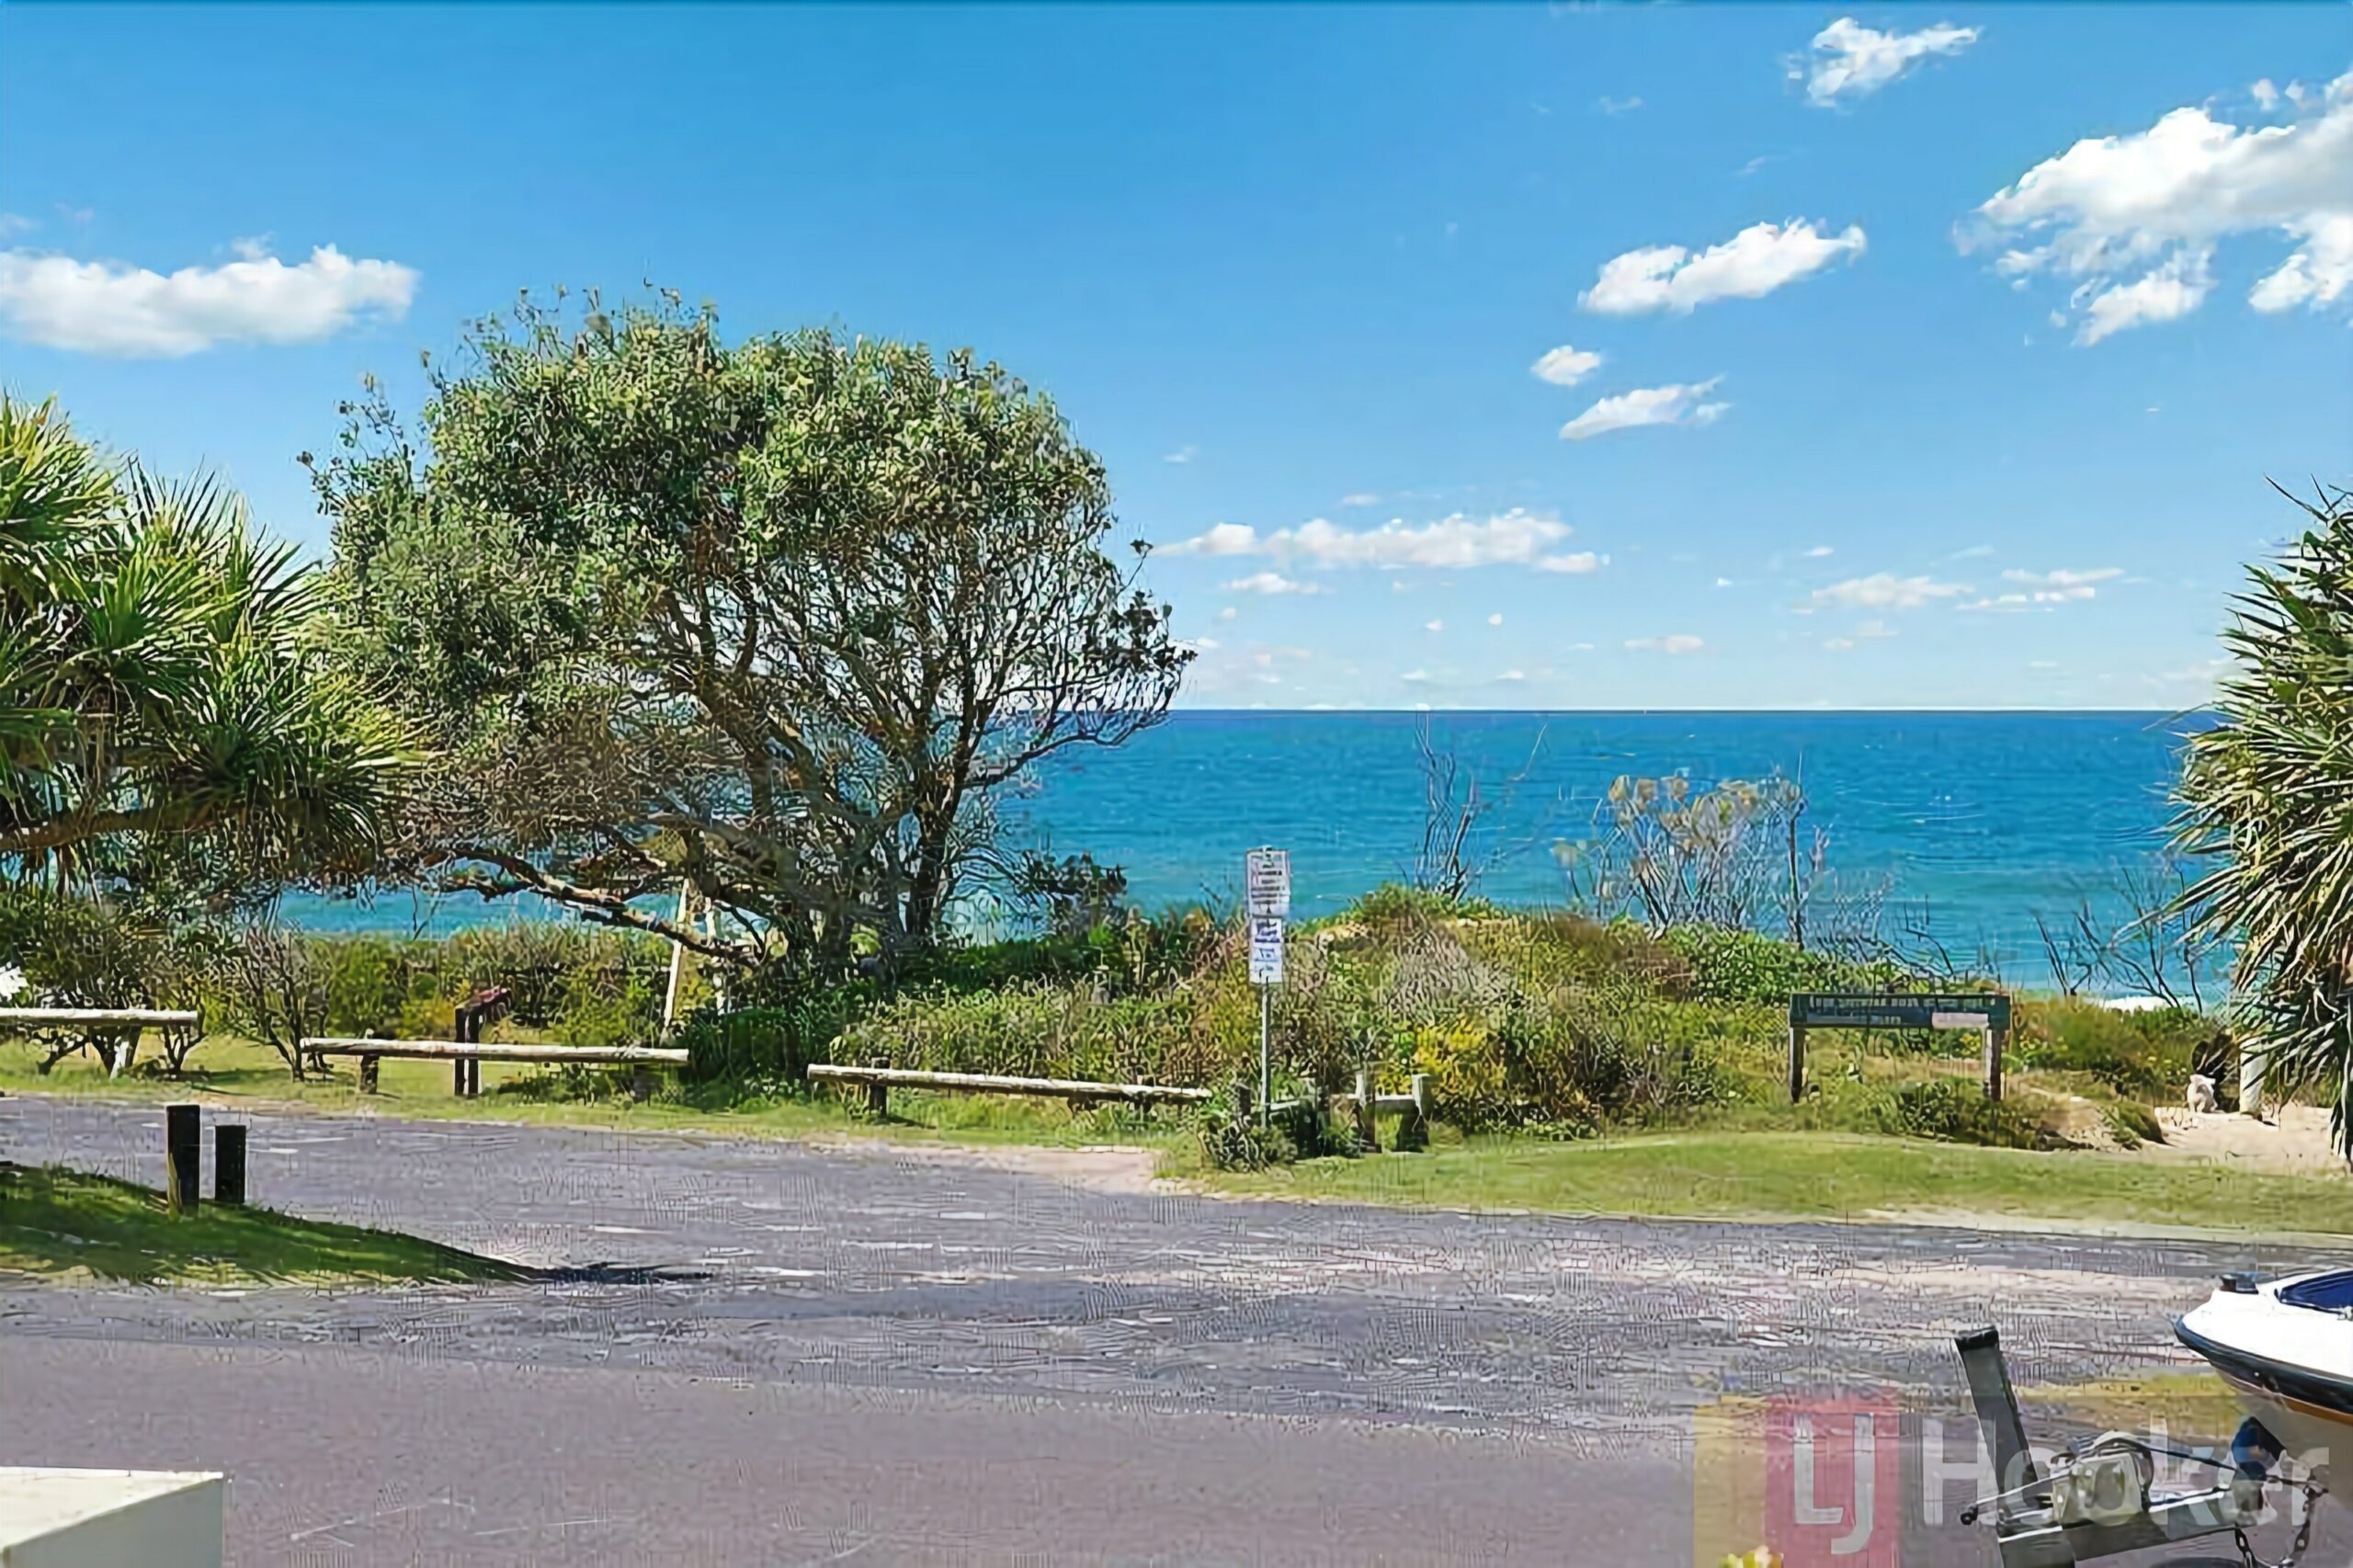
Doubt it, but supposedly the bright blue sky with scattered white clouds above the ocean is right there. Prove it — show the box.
[0,5,2353,709]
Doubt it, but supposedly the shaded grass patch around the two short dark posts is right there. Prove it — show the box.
[0,1165,527,1286]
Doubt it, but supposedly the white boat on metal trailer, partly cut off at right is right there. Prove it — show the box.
[1958,1309,2353,1568]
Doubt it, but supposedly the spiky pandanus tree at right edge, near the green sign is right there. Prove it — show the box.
[2177,490,2353,1152]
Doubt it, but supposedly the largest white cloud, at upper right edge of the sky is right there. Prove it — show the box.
[1960,71,2353,344]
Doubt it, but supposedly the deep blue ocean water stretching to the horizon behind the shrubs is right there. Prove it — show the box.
[294,711,2200,982]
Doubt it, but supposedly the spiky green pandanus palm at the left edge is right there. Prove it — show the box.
[0,398,407,878]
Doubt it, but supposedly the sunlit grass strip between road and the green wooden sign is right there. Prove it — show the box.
[1172,1131,2353,1236]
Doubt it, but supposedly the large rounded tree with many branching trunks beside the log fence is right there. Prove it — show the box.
[315,294,1188,968]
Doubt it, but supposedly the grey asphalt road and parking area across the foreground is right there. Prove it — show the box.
[0,1097,2353,1568]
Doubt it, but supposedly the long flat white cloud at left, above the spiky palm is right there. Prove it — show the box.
[0,244,416,358]
